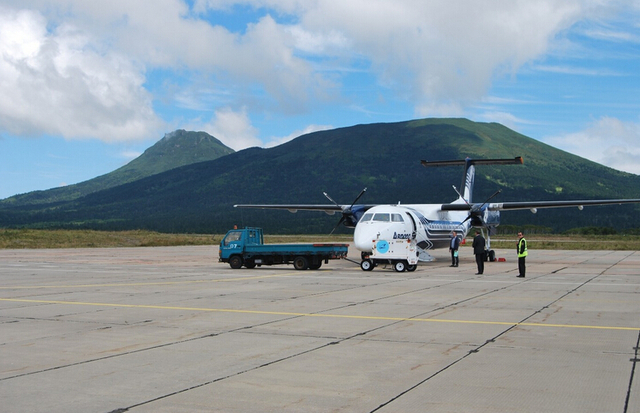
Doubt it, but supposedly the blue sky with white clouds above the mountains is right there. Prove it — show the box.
[0,0,640,198]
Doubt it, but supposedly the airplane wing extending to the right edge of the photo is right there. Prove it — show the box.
[441,199,640,211]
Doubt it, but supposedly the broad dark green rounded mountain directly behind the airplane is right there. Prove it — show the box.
[0,119,640,233]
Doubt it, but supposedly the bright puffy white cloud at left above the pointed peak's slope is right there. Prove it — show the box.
[0,8,160,142]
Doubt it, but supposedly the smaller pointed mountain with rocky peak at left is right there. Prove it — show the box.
[0,129,234,207]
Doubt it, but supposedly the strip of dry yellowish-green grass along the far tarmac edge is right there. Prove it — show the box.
[0,229,640,251]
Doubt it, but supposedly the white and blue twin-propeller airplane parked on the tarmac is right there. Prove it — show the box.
[234,156,640,271]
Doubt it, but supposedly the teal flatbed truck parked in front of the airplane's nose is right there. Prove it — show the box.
[219,227,349,270]
